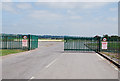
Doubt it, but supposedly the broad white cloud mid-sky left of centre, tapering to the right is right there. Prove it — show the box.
[28,10,82,22]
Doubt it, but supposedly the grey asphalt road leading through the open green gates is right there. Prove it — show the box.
[2,42,118,79]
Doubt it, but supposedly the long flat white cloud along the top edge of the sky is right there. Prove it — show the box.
[35,2,109,9]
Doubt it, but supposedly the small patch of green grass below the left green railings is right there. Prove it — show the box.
[0,49,25,56]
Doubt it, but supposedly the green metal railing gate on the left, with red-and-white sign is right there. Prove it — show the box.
[0,34,38,50]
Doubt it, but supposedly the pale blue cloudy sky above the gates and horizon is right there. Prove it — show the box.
[2,2,118,37]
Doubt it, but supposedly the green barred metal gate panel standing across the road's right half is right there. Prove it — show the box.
[64,37,101,52]
